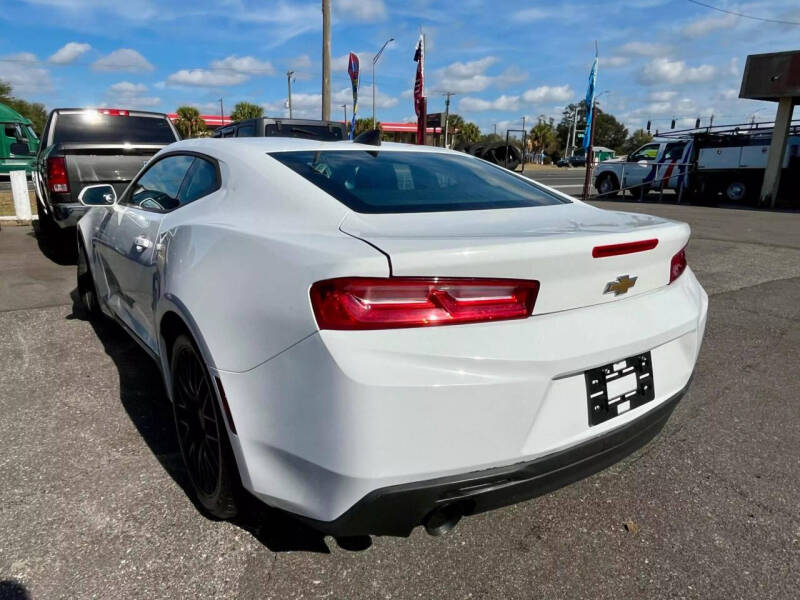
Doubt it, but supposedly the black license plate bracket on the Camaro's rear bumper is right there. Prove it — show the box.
[584,352,655,426]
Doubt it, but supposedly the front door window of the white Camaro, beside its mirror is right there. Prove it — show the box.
[120,155,194,212]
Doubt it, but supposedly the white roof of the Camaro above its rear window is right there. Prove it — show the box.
[164,137,456,156]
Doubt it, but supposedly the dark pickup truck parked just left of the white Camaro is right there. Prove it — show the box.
[33,108,180,233]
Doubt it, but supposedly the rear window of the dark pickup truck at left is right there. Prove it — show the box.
[53,111,176,144]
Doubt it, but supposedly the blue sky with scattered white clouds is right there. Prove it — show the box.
[0,0,800,133]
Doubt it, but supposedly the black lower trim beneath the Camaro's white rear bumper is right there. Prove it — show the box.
[303,384,689,536]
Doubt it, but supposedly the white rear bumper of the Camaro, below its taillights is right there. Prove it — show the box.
[215,269,708,533]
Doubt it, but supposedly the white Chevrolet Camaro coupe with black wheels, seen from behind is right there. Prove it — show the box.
[78,138,708,535]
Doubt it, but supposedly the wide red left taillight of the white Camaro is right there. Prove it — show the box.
[311,277,539,330]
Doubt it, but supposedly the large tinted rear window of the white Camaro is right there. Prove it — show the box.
[270,150,569,213]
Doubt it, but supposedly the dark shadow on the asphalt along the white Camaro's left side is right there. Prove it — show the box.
[67,290,371,553]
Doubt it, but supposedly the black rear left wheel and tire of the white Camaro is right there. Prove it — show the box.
[170,334,241,519]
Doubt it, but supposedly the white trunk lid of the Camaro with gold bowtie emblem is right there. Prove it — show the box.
[340,203,689,314]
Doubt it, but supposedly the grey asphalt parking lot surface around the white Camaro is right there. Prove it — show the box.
[0,203,800,599]
